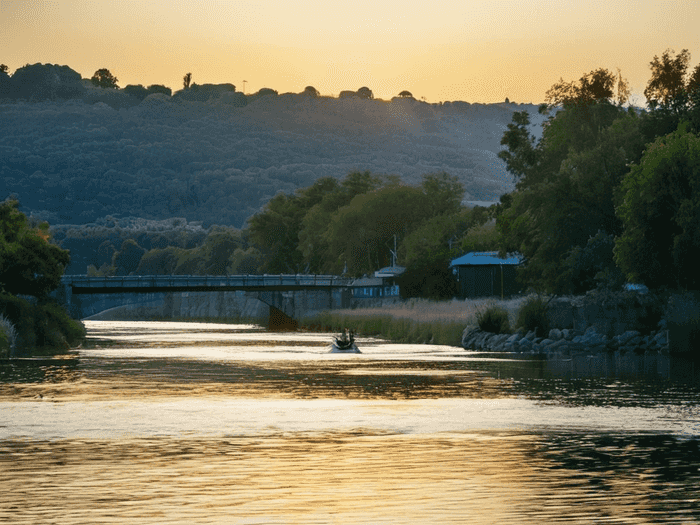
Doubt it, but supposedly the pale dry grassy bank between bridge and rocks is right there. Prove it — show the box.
[300,298,523,346]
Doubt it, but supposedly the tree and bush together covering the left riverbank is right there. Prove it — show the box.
[0,199,85,357]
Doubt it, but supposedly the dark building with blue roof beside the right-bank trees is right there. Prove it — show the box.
[450,252,522,299]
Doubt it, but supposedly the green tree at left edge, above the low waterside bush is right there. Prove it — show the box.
[0,199,70,298]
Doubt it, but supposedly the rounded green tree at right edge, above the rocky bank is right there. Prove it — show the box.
[615,129,700,289]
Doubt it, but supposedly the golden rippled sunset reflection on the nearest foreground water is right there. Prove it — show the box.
[0,430,668,524]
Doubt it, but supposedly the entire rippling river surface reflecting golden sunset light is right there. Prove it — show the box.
[0,321,700,524]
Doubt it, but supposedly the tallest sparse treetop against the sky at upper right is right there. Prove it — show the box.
[644,49,690,108]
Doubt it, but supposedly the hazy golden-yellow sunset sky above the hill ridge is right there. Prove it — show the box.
[0,0,700,103]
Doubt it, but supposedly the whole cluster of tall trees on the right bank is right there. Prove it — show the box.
[497,50,700,293]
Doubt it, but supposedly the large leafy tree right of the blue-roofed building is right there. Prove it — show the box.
[497,101,644,293]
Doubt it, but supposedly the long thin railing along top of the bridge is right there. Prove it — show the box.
[61,274,353,289]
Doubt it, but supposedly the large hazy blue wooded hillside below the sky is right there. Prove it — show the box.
[0,88,542,227]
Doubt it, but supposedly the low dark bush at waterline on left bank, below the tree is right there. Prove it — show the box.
[0,293,86,357]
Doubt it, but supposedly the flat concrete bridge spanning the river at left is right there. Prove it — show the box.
[54,275,352,329]
